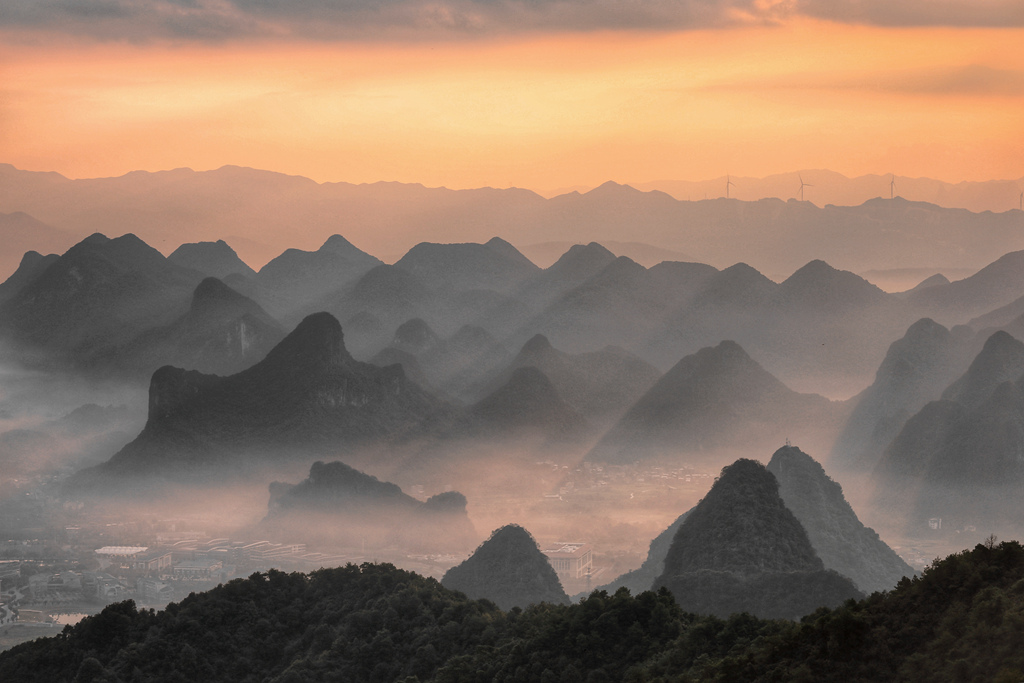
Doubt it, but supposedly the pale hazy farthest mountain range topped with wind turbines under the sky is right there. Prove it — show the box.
[0,165,1024,273]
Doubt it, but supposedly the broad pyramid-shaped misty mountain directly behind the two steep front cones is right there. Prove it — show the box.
[587,341,838,463]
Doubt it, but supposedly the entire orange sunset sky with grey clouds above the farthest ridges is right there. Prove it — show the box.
[0,0,1024,190]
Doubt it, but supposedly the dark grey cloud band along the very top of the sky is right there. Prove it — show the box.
[0,0,1024,42]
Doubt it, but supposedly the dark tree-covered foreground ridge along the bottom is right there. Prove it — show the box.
[6,542,1024,683]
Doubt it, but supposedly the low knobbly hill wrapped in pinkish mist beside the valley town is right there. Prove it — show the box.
[258,461,475,552]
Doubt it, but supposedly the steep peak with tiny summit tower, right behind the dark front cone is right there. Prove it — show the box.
[767,446,914,593]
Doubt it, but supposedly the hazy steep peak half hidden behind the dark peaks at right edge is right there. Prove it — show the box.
[830,318,970,471]
